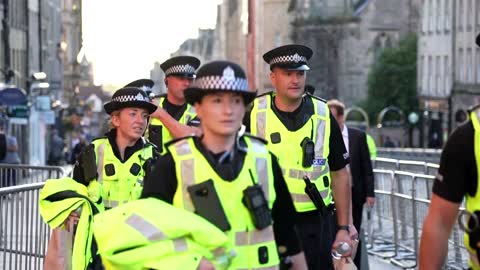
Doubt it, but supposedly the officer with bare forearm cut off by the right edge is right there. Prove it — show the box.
[420,34,480,270]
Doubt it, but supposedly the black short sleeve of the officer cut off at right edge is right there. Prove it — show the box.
[433,121,478,203]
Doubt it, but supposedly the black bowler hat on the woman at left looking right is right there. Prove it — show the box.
[103,87,157,114]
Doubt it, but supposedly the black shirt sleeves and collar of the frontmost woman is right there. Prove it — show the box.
[141,138,301,255]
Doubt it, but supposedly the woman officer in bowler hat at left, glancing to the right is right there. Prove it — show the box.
[73,87,157,209]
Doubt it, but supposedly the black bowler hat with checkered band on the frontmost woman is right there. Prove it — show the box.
[184,61,257,104]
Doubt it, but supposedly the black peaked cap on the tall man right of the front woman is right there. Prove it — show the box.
[263,44,313,70]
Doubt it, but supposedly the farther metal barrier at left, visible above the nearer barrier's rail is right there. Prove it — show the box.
[0,163,65,188]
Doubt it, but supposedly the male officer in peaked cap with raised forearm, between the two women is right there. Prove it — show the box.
[148,56,200,153]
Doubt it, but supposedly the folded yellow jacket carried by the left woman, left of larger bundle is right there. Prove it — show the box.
[39,178,101,270]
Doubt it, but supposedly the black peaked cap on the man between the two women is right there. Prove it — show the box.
[160,56,200,78]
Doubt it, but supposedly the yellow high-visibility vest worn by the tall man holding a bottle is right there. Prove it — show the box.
[250,94,332,212]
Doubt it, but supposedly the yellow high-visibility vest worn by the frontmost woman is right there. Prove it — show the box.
[168,136,279,269]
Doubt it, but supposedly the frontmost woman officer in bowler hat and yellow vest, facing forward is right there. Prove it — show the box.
[142,61,306,269]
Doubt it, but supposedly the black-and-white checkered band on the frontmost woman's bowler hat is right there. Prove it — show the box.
[193,76,248,91]
